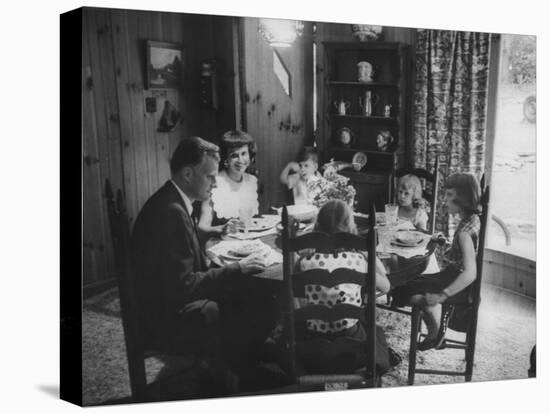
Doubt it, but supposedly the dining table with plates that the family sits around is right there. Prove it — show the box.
[206,213,438,290]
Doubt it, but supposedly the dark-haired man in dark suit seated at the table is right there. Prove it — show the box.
[132,137,270,362]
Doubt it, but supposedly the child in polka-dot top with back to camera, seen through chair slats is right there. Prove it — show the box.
[295,200,401,373]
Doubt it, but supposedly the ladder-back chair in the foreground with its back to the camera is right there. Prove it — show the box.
[282,202,379,390]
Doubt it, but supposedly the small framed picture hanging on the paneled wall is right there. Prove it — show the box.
[145,40,184,89]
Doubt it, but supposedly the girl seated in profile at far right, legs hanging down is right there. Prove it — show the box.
[392,173,481,351]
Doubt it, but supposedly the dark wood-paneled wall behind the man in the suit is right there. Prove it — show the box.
[82,8,229,285]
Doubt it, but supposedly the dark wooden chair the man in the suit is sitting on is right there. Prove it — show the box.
[105,179,198,402]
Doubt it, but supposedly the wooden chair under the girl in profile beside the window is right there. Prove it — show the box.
[408,176,489,385]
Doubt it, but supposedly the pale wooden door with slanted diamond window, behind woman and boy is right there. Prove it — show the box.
[242,18,313,212]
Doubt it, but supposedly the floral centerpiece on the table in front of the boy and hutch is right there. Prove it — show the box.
[313,161,356,208]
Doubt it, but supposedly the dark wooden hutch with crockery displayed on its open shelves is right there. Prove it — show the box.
[320,42,408,213]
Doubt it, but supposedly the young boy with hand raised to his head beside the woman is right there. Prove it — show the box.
[281,147,325,204]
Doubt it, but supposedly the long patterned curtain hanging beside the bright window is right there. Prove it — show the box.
[416,30,490,231]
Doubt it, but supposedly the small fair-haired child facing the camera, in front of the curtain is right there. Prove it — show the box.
[397,174,428,230]
